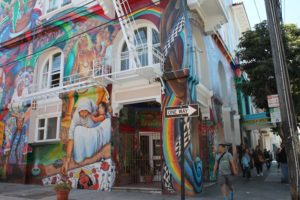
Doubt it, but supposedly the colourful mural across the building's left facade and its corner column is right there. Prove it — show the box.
[0,0,206,194]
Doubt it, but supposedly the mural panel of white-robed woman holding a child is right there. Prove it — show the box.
[42,87,115,190]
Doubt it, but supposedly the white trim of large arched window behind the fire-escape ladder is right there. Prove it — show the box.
[116,21,159,72]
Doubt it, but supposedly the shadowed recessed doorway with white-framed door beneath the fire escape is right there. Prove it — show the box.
[113,102,162,189]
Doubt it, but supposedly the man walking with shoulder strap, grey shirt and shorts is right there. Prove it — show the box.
[213,144,237,200]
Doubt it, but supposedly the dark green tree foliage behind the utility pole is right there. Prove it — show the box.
[238,21,300,119]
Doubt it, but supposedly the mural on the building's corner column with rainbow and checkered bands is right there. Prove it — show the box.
[160,0,203,194]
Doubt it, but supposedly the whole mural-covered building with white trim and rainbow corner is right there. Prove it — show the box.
[0,0,247,194]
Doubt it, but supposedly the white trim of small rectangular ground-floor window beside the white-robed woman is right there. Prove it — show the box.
[34,113,61,143]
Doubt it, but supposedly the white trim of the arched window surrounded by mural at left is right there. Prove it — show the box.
[37,49,64,91]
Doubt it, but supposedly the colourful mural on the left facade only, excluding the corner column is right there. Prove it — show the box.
[0,0,120,190]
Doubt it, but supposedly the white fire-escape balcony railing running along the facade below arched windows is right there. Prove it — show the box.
[12,46,164,103]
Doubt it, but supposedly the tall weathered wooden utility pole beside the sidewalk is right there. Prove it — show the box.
[265,0,300,200]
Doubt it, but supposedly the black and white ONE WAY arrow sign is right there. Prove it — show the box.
[165,104,199,118]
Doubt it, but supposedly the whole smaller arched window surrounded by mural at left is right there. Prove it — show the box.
[39,51,63,89]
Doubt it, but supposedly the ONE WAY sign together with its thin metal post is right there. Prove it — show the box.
[165,104,200,200]
